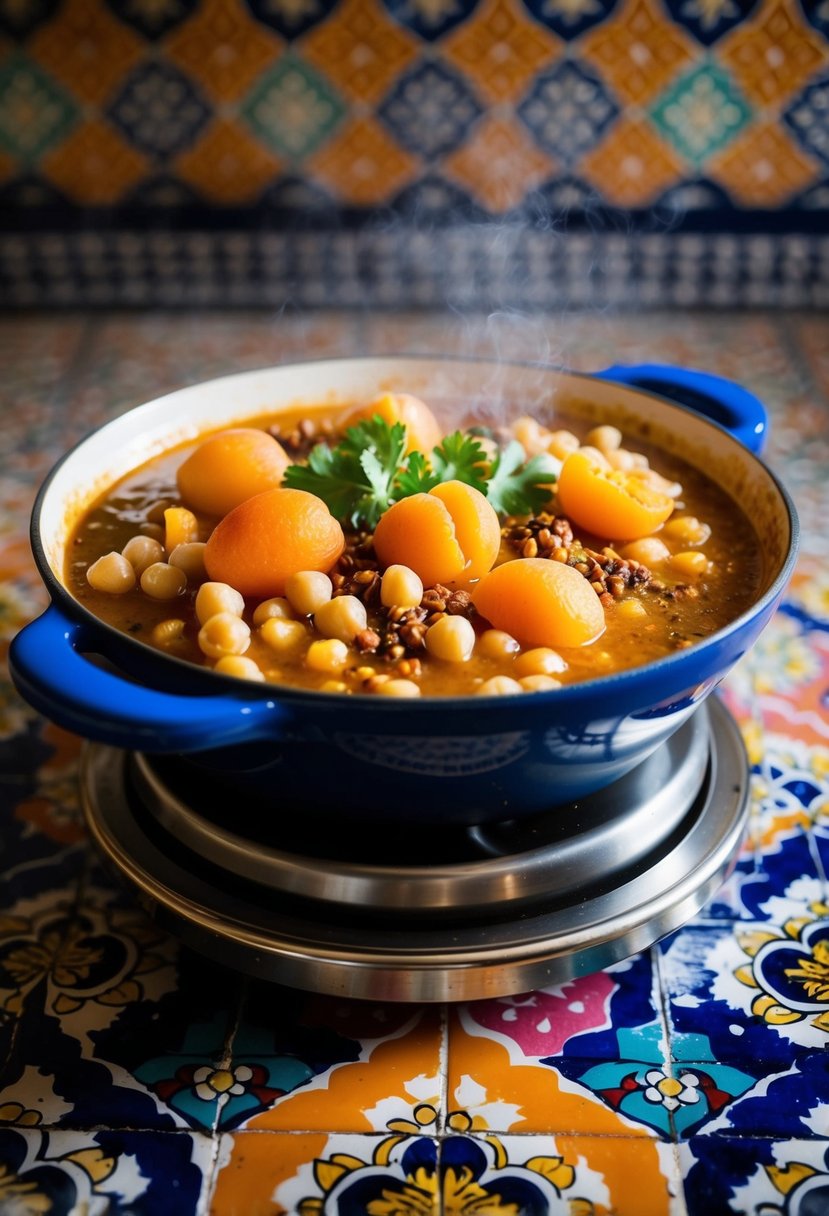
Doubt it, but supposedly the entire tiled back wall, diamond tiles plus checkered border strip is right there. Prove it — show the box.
[0,0,829,309]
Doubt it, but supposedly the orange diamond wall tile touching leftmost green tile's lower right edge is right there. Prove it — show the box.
[41,119,147,207]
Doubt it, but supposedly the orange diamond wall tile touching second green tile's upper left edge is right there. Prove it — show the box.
[167,0,282,101]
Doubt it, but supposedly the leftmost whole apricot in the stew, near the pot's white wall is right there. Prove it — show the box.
[176,427,291,516]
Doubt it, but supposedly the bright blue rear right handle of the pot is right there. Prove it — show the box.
[596,364,768,452]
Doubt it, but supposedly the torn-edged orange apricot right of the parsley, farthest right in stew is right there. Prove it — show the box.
[556,451,673,540]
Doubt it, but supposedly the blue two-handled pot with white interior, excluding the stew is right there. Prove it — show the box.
[11,358,797,822]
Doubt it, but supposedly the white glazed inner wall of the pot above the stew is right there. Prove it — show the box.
[38,358,791,603]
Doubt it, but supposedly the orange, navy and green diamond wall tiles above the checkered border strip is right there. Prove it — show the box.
[0,0,829,298]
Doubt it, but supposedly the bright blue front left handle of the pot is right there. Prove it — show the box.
[9,603,287,751]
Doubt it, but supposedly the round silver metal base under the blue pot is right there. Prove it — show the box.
[81,698,749,1001]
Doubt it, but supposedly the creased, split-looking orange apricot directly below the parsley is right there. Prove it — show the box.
[374,482,501,587]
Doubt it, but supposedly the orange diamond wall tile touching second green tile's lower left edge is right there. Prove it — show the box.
[175,119,280,204]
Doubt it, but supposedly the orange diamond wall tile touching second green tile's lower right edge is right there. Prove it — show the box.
[309,118,417,207]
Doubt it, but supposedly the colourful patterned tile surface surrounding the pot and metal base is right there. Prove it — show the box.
[0,313,829,1216]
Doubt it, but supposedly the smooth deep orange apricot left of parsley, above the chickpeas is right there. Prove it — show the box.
[204,488,345,599]
